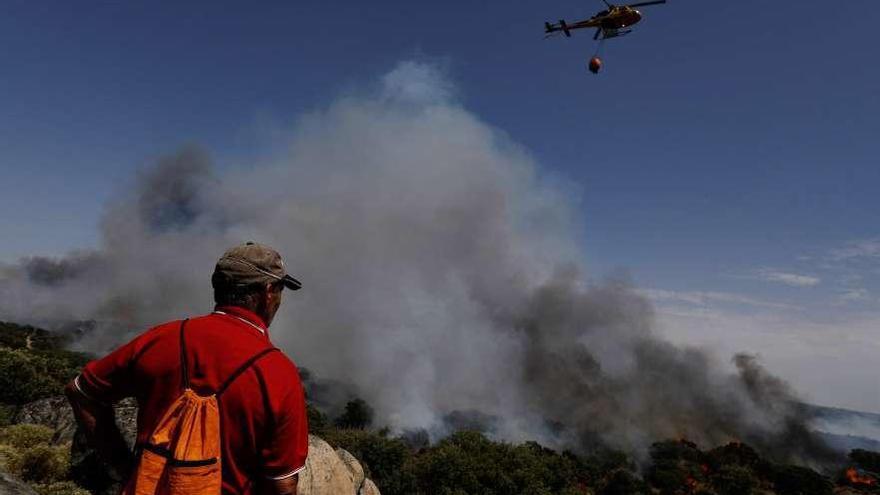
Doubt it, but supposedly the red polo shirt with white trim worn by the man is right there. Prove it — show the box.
[75,307,309,494]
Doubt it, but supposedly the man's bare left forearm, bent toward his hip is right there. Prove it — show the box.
[64,380,134,480]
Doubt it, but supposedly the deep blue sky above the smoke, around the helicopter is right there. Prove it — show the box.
[0,0,880,410]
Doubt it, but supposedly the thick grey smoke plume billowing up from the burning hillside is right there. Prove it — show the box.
[0,63,832,464]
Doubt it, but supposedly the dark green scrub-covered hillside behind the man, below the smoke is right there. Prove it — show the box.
[0,323,880,495]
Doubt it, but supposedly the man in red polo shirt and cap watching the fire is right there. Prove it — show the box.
[66,242,308,495]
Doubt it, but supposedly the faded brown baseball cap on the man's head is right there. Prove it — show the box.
[211,242,302,290]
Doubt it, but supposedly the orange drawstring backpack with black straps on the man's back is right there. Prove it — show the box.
[122,320,278,495]
